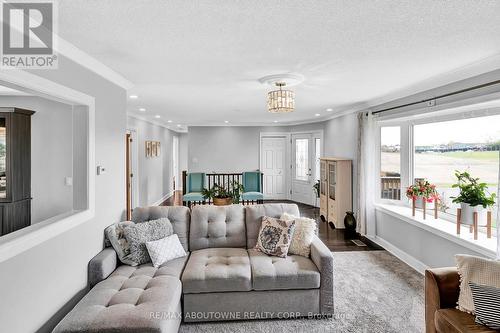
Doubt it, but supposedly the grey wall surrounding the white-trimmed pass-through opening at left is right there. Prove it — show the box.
[0,55,126,333]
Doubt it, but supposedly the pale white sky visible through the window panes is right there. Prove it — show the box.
[381,115,500,146]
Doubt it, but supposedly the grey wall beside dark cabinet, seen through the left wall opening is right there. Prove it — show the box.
[0,96,73,224]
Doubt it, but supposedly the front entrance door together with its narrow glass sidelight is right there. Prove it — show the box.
[291,132,323,206]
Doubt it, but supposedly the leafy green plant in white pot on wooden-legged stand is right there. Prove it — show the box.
[451,171,496,225]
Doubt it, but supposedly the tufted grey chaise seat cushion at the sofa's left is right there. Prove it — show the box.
[53,257,187,333]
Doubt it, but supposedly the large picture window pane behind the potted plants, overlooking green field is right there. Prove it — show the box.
[413,115,500,223]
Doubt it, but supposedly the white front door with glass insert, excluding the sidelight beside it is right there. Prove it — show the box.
[292,133,316,205]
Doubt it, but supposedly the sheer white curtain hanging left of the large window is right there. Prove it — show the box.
[357,112,377,236]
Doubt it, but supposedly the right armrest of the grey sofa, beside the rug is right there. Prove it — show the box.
[311,236,333,315]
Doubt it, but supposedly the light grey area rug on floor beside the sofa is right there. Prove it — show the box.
[179,251,424,333]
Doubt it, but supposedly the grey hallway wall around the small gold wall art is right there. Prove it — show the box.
[127,117,180,206]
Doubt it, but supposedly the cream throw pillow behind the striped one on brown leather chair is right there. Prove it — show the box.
[455,254,500,314]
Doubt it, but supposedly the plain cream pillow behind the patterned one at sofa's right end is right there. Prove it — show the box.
[280,213,316,257]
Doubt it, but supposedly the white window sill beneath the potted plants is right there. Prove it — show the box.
[375,204,497,258]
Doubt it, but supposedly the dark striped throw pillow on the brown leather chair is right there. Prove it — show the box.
[469,282,500,330]
